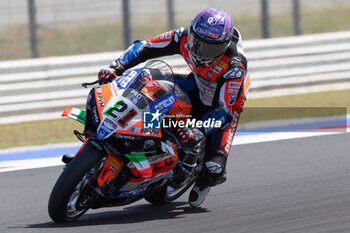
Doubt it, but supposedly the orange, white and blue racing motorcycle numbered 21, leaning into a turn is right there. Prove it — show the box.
[48,61,205,223]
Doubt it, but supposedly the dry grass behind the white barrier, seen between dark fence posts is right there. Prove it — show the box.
[0,4,350,60]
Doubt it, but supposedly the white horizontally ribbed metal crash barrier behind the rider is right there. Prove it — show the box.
[0,31,350,124]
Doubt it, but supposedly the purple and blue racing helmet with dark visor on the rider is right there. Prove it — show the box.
[188,8,234,67]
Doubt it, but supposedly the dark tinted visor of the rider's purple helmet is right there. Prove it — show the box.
[188,31,230,62]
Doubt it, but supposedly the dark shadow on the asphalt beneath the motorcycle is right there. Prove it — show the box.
[21,202,209,228]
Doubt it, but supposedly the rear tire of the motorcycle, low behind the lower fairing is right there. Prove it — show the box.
[145,180,195,205]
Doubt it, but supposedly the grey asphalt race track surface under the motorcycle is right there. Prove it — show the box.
[0,133,350,233]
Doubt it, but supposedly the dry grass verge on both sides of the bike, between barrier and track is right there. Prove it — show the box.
[0,90,350,149]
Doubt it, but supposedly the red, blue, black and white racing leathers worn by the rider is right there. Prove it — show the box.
[106,28,250,186]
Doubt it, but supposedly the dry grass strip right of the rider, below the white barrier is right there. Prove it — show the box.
[240,90,350,123]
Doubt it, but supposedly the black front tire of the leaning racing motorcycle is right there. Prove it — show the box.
[48,144,105,223]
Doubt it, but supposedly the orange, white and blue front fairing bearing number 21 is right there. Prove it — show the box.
[94,61,176,140]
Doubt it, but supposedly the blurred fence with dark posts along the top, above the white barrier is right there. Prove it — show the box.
[0,0,350,60]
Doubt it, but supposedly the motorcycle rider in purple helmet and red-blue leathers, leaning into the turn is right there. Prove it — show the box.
[98,8,250,207]
